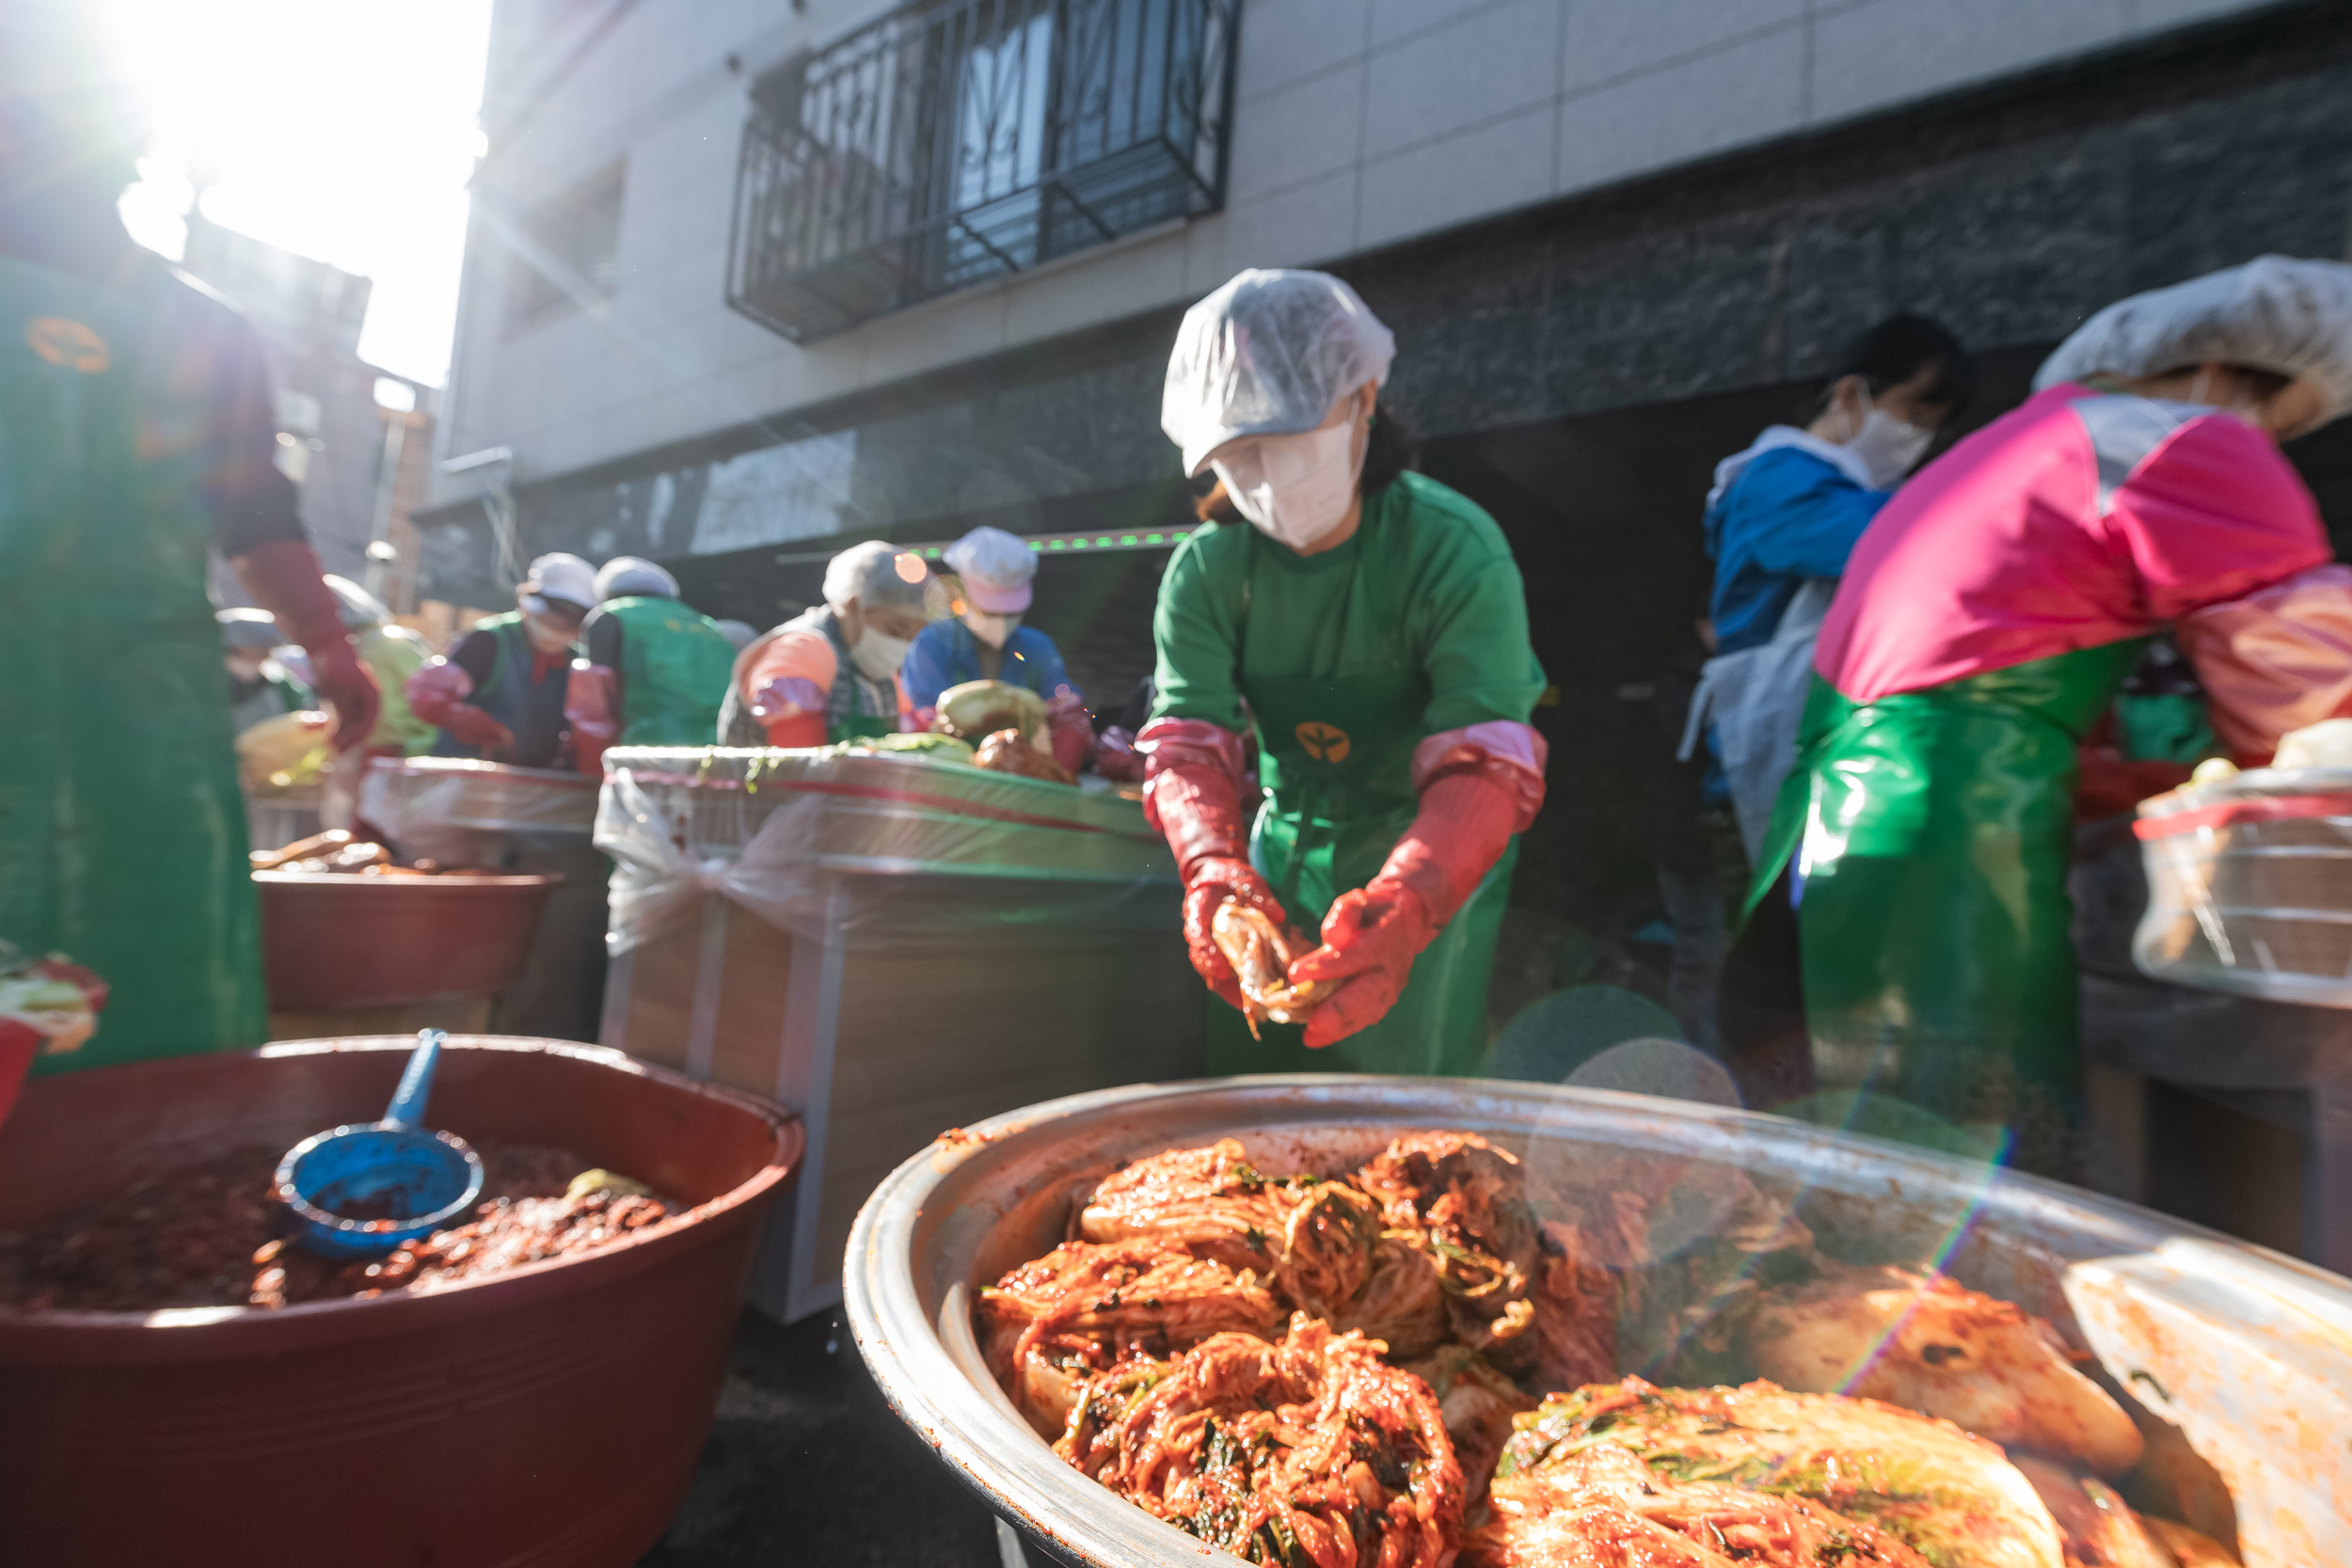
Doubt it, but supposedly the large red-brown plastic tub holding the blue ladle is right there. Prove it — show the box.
[0,1037,803,1568]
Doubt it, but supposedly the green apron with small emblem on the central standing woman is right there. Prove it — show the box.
[1209,529,1519,1077]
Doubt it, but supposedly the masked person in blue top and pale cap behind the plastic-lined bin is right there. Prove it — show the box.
[903,529,1094,773]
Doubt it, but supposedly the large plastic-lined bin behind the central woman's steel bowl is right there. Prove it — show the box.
[597,748,1207,1322]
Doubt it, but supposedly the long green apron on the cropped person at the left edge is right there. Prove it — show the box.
[0,259,263,1072]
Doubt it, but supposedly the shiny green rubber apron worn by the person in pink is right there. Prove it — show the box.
[1748,640,2143,1126]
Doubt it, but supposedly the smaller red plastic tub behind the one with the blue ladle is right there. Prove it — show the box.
[254,872,563,1010]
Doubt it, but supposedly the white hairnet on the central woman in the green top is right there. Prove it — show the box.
[1160,268,1397,477]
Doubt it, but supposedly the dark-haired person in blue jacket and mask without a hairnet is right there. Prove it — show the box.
[1682,315,1974,858]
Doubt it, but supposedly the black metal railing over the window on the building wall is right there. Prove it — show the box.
[727,0,1240,341]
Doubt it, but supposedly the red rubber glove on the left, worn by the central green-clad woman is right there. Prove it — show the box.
[1136,720,1287,1008]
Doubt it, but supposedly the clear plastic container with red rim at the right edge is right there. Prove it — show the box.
[2131,768,2352,1008]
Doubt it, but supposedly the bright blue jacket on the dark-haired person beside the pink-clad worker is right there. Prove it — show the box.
[1706,447,1894,654]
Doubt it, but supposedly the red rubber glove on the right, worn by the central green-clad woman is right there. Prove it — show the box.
[1289,764,1541,1046]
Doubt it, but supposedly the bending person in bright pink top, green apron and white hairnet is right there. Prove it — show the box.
[1750,256,2352,1173]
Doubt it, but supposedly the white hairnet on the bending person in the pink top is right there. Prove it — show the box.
[2035,256,2352,423]
